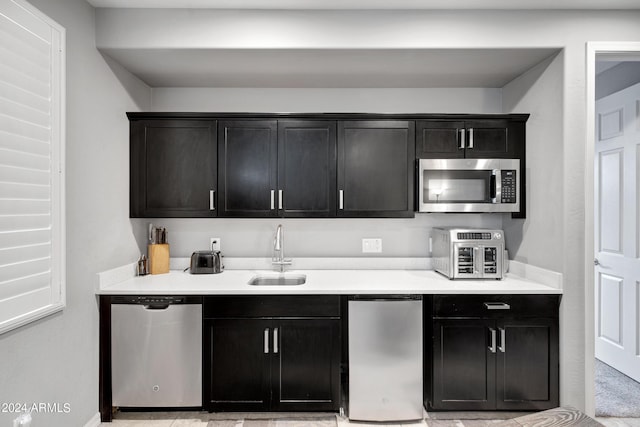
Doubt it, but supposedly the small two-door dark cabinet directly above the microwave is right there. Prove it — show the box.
[416,119,517,159]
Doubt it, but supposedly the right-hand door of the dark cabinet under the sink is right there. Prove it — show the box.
[271,319,341,411]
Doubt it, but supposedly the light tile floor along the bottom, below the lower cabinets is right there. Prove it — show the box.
[100,411,640,427]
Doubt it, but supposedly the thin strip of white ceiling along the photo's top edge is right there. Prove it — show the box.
[87,0,640,10]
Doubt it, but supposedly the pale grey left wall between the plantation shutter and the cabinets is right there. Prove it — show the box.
[0,0,150,427]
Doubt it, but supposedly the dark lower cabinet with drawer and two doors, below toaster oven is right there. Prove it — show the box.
[425,296,559,410]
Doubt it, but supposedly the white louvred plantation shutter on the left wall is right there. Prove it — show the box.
[0,0,65,333]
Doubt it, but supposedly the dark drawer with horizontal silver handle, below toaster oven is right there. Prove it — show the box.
[433,295,560,318]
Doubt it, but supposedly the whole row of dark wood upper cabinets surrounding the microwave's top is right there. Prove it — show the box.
[127,113,528,218]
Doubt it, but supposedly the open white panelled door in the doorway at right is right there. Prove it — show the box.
[594,80,640,381]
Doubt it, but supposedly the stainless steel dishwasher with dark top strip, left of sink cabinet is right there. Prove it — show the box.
[111,296,202,407]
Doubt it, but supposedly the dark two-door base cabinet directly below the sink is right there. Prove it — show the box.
[203,296,341,412]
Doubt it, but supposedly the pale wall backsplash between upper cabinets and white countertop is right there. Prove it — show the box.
[130,214,504,258]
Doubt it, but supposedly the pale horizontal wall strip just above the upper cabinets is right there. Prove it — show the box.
[152,88,502,113]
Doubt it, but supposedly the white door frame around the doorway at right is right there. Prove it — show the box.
[584,42,640,416]
